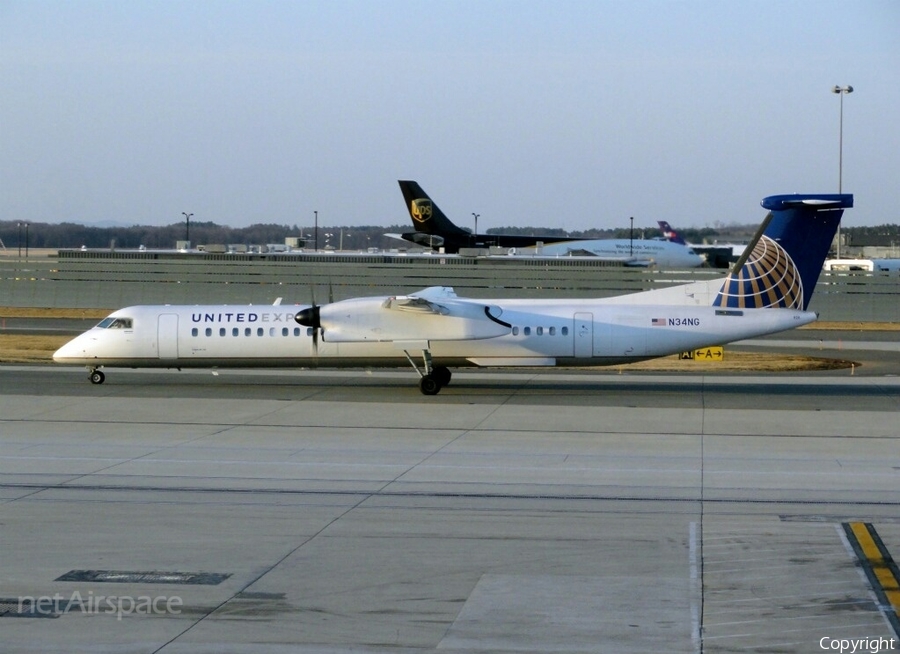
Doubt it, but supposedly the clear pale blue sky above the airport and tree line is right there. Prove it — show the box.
[0,0,900,231]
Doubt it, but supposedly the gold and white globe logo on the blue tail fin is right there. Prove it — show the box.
[713,236,803,309]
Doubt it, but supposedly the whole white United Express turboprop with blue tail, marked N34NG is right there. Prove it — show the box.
[53,195,853,395]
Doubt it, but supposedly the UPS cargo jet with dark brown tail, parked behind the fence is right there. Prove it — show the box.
[399,180,704,268]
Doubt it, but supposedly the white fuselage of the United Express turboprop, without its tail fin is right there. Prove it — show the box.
[53,297,815,368]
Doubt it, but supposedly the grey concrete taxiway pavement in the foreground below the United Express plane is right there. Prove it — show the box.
[0,366,900,654]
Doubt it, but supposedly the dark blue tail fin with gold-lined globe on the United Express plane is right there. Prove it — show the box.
[713,194,853,311]
